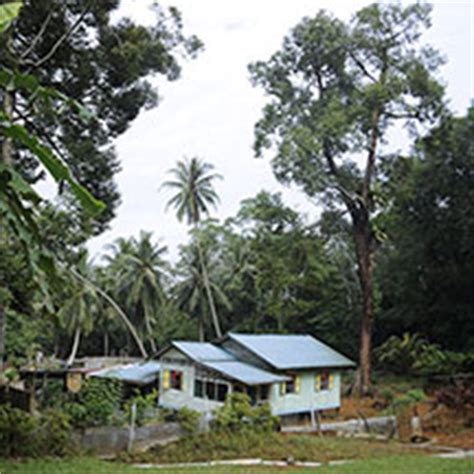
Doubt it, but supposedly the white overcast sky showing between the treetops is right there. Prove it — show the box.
[89,0,474,260]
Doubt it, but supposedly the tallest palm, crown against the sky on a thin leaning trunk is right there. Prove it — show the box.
[163,157,222,337]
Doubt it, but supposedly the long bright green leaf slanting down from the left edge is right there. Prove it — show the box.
[0,117,105,215]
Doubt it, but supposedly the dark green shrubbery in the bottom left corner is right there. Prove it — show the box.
[0,405,76,457]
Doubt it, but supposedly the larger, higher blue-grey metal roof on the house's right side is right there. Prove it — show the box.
[228,333,355,370]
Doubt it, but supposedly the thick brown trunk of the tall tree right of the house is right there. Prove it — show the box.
[354,210,374,396]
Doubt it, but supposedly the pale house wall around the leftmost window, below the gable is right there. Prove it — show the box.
[159,348,231,413]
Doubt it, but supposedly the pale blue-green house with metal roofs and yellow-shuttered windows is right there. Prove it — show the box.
[157,333,355,416]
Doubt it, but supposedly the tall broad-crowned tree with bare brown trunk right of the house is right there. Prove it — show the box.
[250,3,443,393]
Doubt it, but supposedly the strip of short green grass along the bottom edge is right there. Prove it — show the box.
[0,456,474,474]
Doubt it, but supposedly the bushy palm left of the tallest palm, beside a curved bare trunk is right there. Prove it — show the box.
[105,231,168,352]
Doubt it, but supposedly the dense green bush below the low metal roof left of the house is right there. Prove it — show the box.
[64,377,122,428]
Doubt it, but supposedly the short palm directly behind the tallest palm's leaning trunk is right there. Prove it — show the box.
[174,241,230,341]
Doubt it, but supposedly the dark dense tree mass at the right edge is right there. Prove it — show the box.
[379,107,474,351]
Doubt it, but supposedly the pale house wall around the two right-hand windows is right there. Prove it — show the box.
[270,370,341,415]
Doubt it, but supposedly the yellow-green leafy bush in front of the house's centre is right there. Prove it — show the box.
[213,393,278,432]
